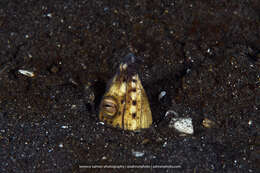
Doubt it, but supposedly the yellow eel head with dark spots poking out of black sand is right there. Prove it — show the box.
[99,56,152,130]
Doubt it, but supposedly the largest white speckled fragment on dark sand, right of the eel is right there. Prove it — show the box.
[169,118,194,135]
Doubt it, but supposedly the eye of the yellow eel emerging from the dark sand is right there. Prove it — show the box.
[102,97,118,117]
